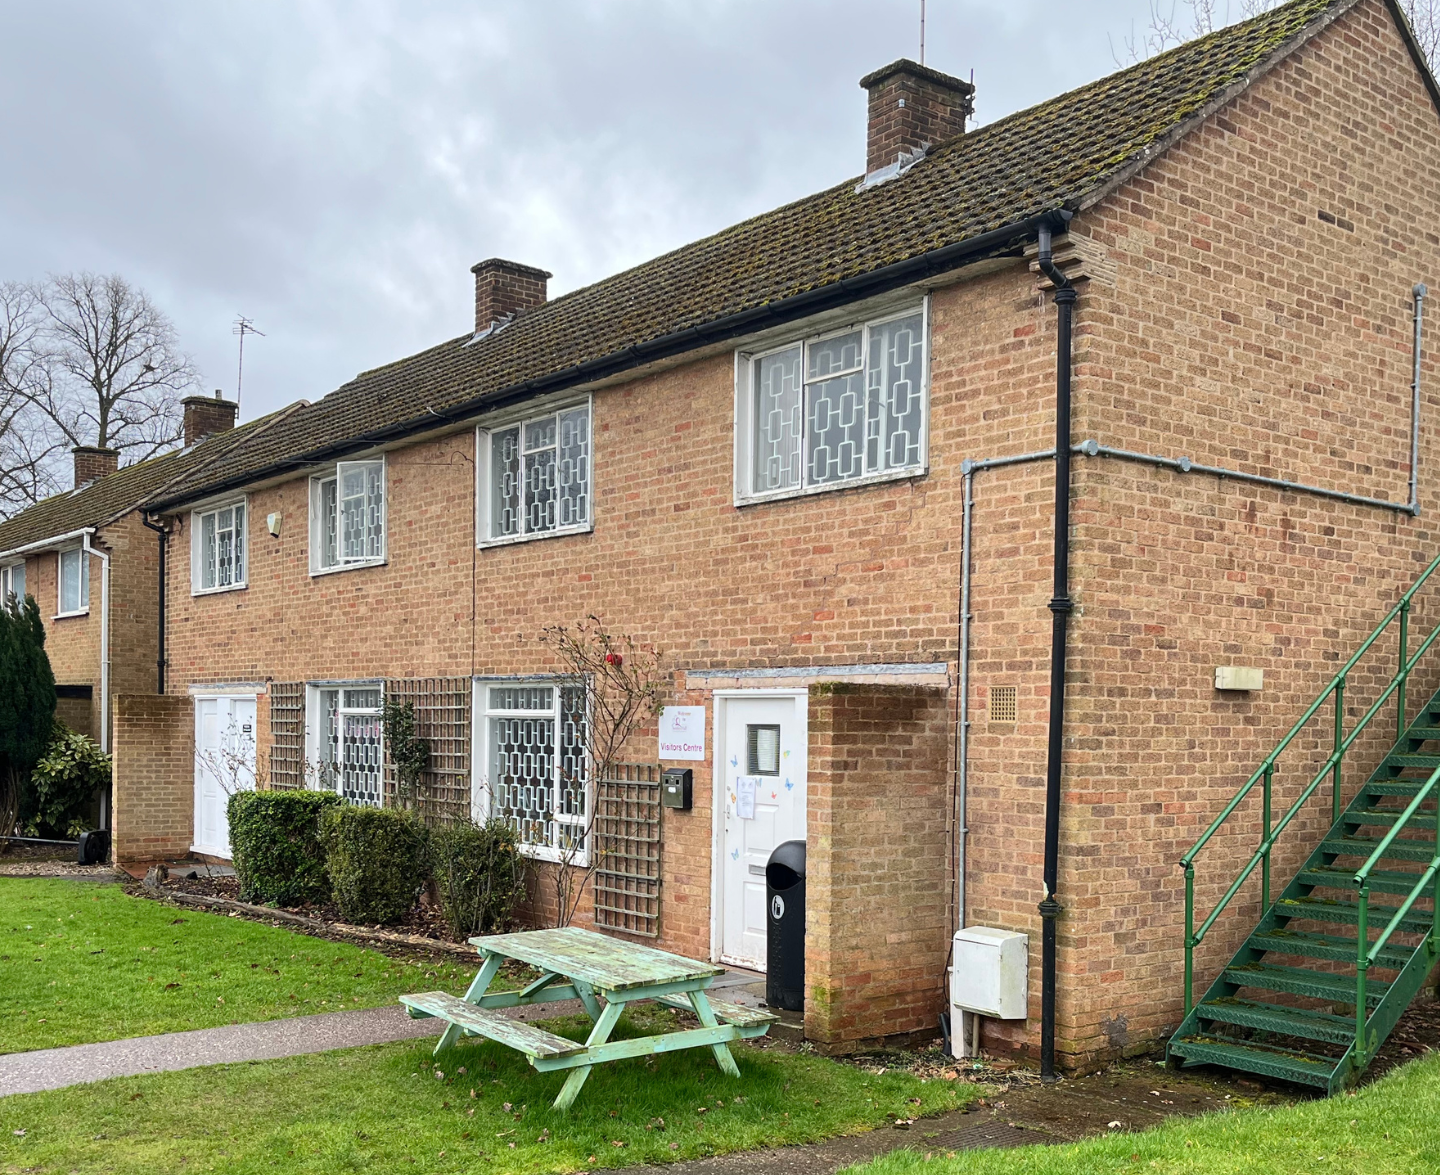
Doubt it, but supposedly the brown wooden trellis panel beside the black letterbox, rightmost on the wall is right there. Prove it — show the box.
[595,763,660,937]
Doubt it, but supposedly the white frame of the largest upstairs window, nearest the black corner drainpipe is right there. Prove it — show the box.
[734,297,930,505]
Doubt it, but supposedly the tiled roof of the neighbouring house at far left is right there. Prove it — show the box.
[0,403,305,553]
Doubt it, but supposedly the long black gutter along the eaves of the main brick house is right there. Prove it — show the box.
[150,209,1066,513]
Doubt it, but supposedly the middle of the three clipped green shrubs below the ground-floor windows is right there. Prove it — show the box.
[320,805,426,923]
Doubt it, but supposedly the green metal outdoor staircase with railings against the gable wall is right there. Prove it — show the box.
[1168,559,1440,1093]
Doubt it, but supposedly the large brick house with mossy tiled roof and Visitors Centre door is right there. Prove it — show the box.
[115,0,1440,1067]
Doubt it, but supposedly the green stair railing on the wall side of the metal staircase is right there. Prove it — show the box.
[1179,556,1440,1015]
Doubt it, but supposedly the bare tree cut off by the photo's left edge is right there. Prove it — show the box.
[0,282,63,518]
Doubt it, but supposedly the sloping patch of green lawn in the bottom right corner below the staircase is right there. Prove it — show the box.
[850,1057,1440,1175]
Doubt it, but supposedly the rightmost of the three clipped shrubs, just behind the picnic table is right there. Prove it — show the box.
[431,819,524,939]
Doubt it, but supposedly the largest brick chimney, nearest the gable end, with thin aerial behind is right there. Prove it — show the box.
[860,58,975,177]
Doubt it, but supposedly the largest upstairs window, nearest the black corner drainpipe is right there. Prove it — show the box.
[736,307,929,503]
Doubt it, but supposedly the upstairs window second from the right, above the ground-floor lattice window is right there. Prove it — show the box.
[477,403,590,544]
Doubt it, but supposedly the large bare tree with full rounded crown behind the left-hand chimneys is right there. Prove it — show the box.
[23,274,199,461]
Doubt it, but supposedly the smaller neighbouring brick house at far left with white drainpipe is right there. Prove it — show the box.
[0,393,289,777]
